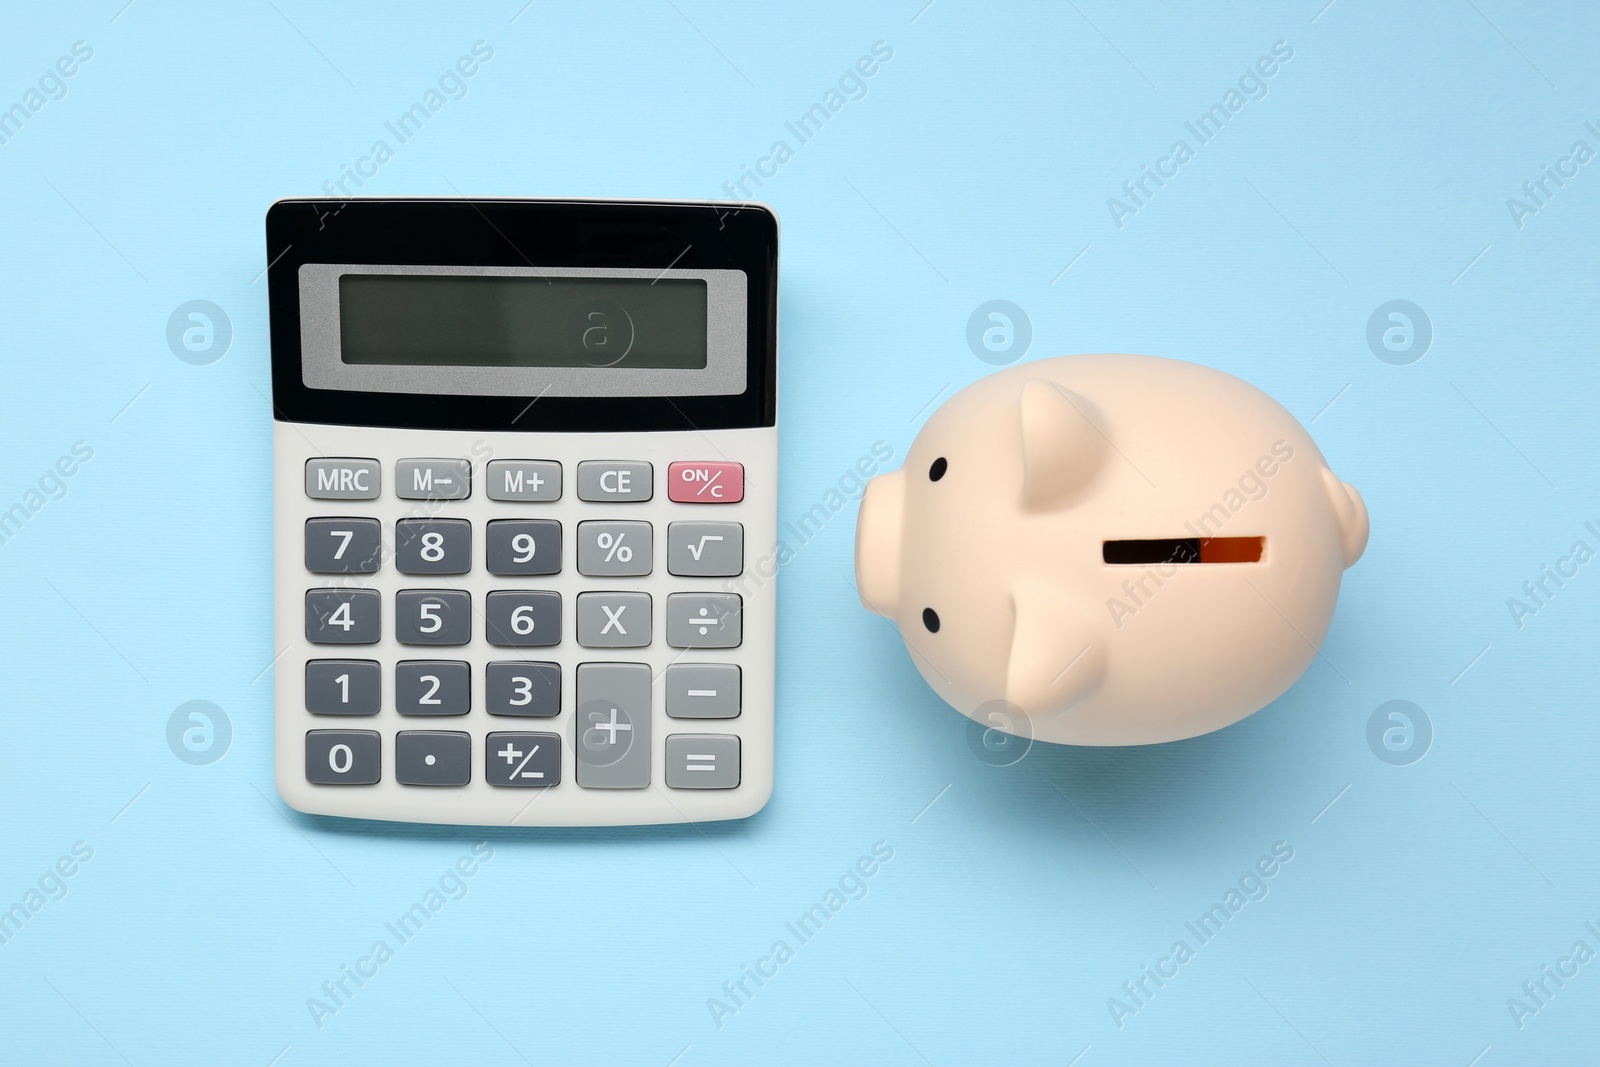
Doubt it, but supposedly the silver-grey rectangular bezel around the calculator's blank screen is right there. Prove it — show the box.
[299,262,749,397]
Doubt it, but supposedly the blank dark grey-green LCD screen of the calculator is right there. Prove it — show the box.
[339,274,707,370]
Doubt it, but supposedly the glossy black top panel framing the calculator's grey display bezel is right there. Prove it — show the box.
[266,198,778,432]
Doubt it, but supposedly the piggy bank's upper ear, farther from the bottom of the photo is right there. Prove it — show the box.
[1021,378,1107,510]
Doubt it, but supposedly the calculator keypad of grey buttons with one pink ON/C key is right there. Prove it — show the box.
[304,458,761,806]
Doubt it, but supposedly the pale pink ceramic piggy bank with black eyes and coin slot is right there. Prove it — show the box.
[856,355,1368,745]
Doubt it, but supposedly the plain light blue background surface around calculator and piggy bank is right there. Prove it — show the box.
[0,0,1600,1067]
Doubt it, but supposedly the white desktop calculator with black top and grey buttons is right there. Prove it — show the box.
[266,198,778,825]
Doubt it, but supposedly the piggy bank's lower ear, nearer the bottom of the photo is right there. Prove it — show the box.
[1005,582,1106,718]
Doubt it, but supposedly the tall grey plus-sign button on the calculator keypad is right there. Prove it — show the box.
[573,664,650,789]
